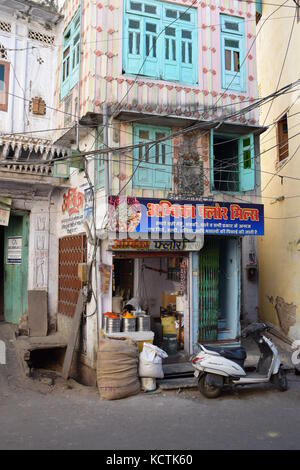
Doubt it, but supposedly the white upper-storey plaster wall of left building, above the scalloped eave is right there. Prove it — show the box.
[0,12,57,141]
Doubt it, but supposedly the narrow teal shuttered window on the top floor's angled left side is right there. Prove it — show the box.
[60,12,80,100]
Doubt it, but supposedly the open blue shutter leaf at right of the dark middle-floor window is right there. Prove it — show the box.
[239,134,255,191]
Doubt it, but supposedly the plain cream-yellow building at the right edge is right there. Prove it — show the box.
[257,2,300,340]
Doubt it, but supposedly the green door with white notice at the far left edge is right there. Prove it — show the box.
[4,214,29,324]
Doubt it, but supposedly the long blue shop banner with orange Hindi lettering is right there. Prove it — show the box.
[108,196,264,240]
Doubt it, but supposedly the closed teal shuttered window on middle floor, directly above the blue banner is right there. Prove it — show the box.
[132,126,172,189]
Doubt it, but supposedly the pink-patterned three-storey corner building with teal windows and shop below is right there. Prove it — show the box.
[47,0,263,382]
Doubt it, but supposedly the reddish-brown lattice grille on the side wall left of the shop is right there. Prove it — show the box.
[57,235,87,317]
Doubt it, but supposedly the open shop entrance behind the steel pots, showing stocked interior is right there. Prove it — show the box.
[113,252,189,362]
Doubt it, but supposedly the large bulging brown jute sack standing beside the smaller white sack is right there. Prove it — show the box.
[97,337,140,400]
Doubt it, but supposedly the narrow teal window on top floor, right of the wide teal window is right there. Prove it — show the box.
[221,15,246,91]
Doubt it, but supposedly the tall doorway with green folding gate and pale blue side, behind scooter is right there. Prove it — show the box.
[198,237,240,342]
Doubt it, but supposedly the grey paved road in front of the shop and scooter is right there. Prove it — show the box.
[0,324,300,449]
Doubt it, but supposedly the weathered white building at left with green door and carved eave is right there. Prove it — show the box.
[0,0,66,330]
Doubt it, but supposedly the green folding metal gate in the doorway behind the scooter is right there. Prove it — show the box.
[199,238,220,342]
